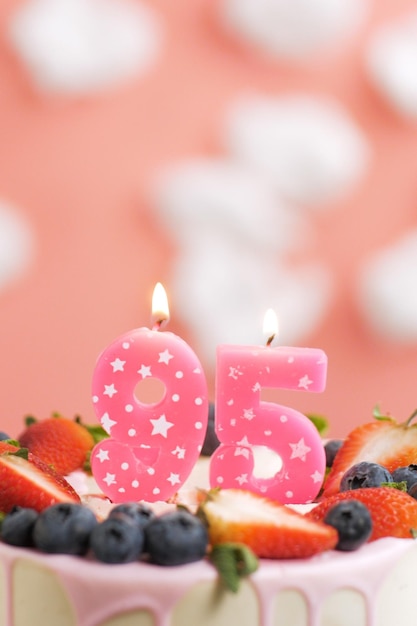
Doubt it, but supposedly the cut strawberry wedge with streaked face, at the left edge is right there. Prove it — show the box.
[0,450,80,513]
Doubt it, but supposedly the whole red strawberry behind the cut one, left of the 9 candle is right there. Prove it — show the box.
[19,416,94,475]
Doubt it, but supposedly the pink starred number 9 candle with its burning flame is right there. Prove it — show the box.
[91,283,208,502]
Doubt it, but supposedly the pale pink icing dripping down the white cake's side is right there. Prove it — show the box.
[0,539,413,626]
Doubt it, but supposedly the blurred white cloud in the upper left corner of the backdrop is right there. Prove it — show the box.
[9,0,161,95]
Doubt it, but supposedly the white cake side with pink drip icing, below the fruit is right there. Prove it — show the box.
[0,538,417,626]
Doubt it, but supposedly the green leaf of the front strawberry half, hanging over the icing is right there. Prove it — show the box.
[209,543,259,593]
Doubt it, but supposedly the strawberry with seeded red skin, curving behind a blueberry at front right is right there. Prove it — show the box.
[306,487,417,541]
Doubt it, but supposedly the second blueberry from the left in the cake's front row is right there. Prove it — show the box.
[33,502,98,555]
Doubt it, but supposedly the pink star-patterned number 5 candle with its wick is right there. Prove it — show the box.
[210,310,327,503]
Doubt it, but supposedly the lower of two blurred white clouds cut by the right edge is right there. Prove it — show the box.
[358,230,417,344]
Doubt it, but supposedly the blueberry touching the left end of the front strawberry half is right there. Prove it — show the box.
[145,510,208,565]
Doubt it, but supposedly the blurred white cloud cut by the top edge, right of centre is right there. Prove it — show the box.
[219,0,369,60]
